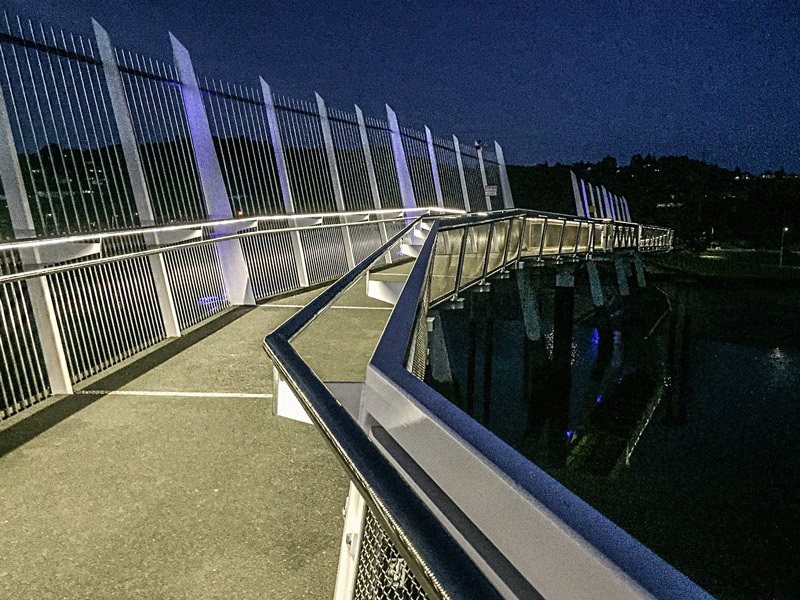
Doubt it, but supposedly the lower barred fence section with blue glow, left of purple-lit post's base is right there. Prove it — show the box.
[164,233,230,329]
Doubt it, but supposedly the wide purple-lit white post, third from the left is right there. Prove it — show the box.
[169,33,256,305]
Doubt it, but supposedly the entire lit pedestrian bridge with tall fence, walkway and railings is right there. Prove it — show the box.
[0,10,707,599]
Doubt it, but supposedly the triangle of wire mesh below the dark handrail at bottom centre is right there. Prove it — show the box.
[353,509,428,600]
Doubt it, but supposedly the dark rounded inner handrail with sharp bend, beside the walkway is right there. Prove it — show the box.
[264,217,500,599]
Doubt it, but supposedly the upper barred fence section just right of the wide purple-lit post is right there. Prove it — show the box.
[201,80,283,216]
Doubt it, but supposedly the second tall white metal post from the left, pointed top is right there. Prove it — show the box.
[92,19,181,337]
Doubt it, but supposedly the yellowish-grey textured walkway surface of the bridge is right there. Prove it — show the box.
[0,266,408,600]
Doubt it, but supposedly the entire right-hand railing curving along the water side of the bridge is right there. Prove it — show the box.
[265,210,710,599]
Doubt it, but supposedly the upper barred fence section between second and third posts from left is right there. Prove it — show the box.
[116,49,205,223]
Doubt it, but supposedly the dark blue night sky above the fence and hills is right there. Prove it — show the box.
[7,0,800,172]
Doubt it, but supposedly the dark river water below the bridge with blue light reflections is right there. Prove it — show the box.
[432,282,800,599]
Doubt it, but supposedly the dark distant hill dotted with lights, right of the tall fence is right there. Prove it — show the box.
[508,154,800,248]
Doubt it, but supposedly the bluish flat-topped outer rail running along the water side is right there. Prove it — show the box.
[369,213,711,600]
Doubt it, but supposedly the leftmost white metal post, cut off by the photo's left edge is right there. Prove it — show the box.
[0,89,72,394]
